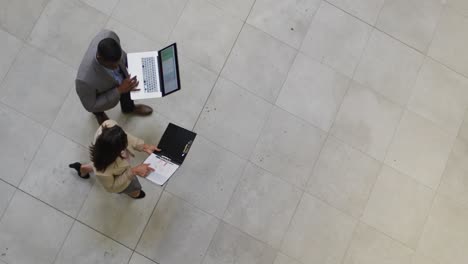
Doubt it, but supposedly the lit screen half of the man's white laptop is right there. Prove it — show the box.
[158,43,180,96]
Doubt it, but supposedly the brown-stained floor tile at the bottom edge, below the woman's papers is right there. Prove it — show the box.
[136,192,219,264]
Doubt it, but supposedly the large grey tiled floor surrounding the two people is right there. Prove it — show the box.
[0,0,468,264]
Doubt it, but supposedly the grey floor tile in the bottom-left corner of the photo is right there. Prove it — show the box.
[0,191,73,264]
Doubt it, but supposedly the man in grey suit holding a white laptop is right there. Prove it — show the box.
[75,30,153,124]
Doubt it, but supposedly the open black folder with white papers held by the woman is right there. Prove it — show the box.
[144,123,197,185]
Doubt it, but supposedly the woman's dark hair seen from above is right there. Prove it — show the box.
[89,126,128,171]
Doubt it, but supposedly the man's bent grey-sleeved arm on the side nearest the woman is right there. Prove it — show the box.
[75,80,120,113]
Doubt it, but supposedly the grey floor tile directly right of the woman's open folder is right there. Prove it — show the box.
[166,135,246,218]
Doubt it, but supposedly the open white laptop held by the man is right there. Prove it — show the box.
[127,43,180,100]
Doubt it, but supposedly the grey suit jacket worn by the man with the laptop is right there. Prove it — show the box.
[75,30,128,113]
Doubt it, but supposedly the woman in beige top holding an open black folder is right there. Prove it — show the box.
[69,120,160,199]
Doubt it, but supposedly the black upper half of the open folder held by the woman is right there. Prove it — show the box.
[155,123,197,165]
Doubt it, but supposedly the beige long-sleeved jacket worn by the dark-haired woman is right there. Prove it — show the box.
[94,120,144,193]
